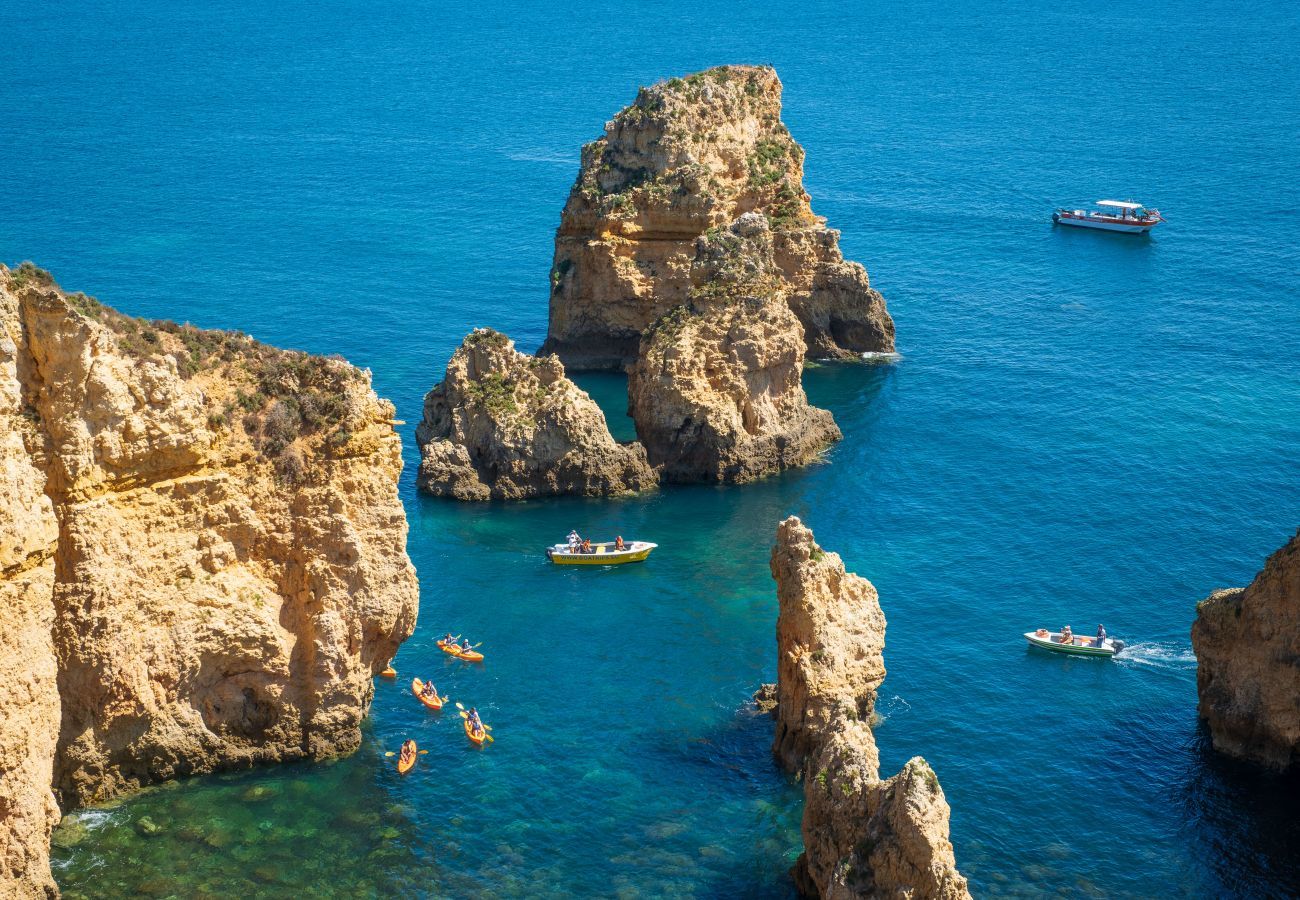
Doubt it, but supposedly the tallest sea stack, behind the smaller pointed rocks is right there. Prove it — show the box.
[542,65,894,369]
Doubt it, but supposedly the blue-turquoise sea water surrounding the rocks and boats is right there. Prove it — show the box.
[0,0,1300,897]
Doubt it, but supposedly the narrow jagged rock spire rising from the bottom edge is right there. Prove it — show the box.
[771,516,970,900]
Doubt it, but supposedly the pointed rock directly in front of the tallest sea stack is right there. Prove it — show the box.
[628,212,840,483]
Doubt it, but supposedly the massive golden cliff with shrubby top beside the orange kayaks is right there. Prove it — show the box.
[0,264,417,896]
